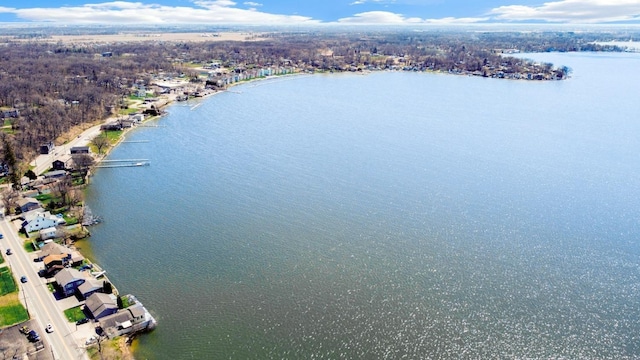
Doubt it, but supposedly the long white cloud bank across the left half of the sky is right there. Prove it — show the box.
[0,0,319,24]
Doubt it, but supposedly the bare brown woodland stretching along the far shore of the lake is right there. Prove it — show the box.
[0,29,632,166]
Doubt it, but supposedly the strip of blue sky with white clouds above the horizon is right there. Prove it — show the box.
[0,0,640,25]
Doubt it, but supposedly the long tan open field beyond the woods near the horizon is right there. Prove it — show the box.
[13,32,264,44]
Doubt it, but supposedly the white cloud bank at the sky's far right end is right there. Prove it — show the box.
[489,0,640,23]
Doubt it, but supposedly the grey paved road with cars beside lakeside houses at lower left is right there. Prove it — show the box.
[0,220,88,360]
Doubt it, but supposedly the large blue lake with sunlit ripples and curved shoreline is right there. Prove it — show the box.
[87,53,640,359]
